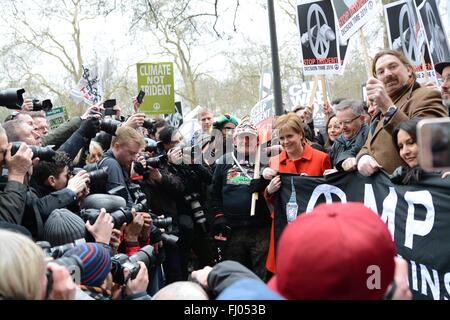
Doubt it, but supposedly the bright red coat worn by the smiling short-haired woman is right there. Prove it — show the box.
[264,144,332,273]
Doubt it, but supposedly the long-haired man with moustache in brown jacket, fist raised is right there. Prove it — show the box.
[357,50,448,176]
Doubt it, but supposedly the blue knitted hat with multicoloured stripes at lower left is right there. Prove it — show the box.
[64,243,111,287]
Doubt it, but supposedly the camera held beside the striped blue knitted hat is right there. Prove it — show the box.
[111,245,157,285]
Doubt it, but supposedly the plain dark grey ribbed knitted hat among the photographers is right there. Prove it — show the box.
[44,209,86,247]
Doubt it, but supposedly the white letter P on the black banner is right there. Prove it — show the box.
[405,190,435,249]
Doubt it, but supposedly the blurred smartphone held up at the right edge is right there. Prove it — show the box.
[417,117,450,171]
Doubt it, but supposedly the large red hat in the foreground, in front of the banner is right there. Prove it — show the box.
[269,203,395,300]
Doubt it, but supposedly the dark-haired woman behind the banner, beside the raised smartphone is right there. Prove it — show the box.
[391,118,449,184]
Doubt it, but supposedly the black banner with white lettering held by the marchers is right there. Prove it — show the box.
[274,172,450,300]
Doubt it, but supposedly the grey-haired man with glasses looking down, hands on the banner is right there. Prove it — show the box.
[330,100,368,171]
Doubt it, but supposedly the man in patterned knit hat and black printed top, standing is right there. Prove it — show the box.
[212,123,270,278]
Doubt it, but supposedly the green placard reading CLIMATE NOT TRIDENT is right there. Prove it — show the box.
[136,62,175,115]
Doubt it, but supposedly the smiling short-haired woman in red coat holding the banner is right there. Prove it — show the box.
[263,113,331,273]
